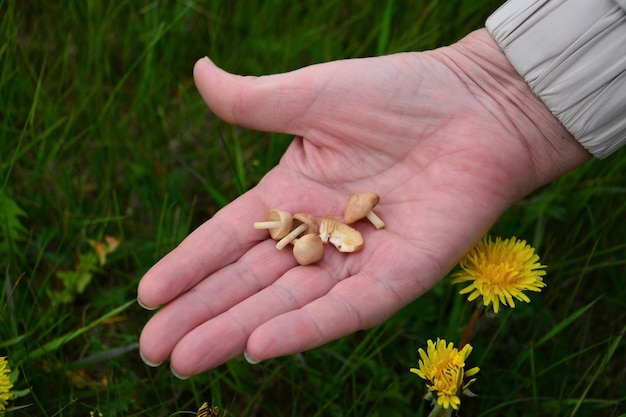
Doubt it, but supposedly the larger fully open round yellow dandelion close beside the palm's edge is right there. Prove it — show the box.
[452,237,546,313]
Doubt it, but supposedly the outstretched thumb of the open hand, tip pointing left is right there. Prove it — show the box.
[193,58,319,135]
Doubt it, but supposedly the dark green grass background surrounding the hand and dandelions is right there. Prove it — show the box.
[0,0,626,417]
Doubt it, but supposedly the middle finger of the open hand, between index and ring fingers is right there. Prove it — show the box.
[139,240,296,365]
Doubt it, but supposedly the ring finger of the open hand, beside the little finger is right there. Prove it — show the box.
[171,256,346,377]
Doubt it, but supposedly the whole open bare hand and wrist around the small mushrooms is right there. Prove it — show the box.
[138,30,589,377]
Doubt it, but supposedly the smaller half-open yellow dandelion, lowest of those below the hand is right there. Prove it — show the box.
[410,339,479,410]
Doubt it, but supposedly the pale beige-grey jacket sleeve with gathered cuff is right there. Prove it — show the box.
[485,0,626,158]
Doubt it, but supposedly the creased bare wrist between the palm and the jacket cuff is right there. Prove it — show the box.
[447,29,591,190]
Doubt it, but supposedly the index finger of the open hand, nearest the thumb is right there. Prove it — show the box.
[137,191,276,308]
